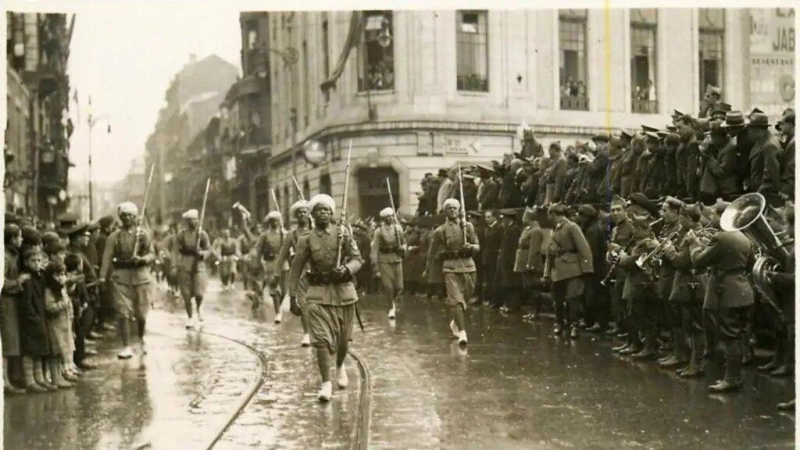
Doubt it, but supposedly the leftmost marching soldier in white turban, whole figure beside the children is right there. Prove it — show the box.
[98,202,155,359]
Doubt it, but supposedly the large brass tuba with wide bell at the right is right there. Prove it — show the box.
[719,193,794,313]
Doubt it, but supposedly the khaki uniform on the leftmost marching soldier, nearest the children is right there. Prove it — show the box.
[100,228,153,319]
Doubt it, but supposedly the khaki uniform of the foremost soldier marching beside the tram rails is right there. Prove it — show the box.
[289,225,362,352]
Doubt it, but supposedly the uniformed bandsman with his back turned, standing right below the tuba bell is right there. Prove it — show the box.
[686,213,753,393]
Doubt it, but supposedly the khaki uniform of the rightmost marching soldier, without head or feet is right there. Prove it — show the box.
[428,220,478,308]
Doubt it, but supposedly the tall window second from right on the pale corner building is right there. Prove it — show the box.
[631,8,658,114]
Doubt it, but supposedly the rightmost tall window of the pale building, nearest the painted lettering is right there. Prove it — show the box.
[699,8,725,99]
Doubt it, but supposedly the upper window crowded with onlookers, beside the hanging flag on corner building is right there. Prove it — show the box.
[358,11,394,91]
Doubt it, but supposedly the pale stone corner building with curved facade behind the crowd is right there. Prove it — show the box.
[269,9,794,216]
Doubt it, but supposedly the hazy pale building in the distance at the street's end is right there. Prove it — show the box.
[145,55,239,223]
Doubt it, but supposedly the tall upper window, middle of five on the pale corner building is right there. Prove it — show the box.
[558,9,589,110]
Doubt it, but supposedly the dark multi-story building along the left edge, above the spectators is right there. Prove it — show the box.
[4,12,75,218]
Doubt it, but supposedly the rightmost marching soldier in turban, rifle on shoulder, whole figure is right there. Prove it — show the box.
[426,199,480,345]
